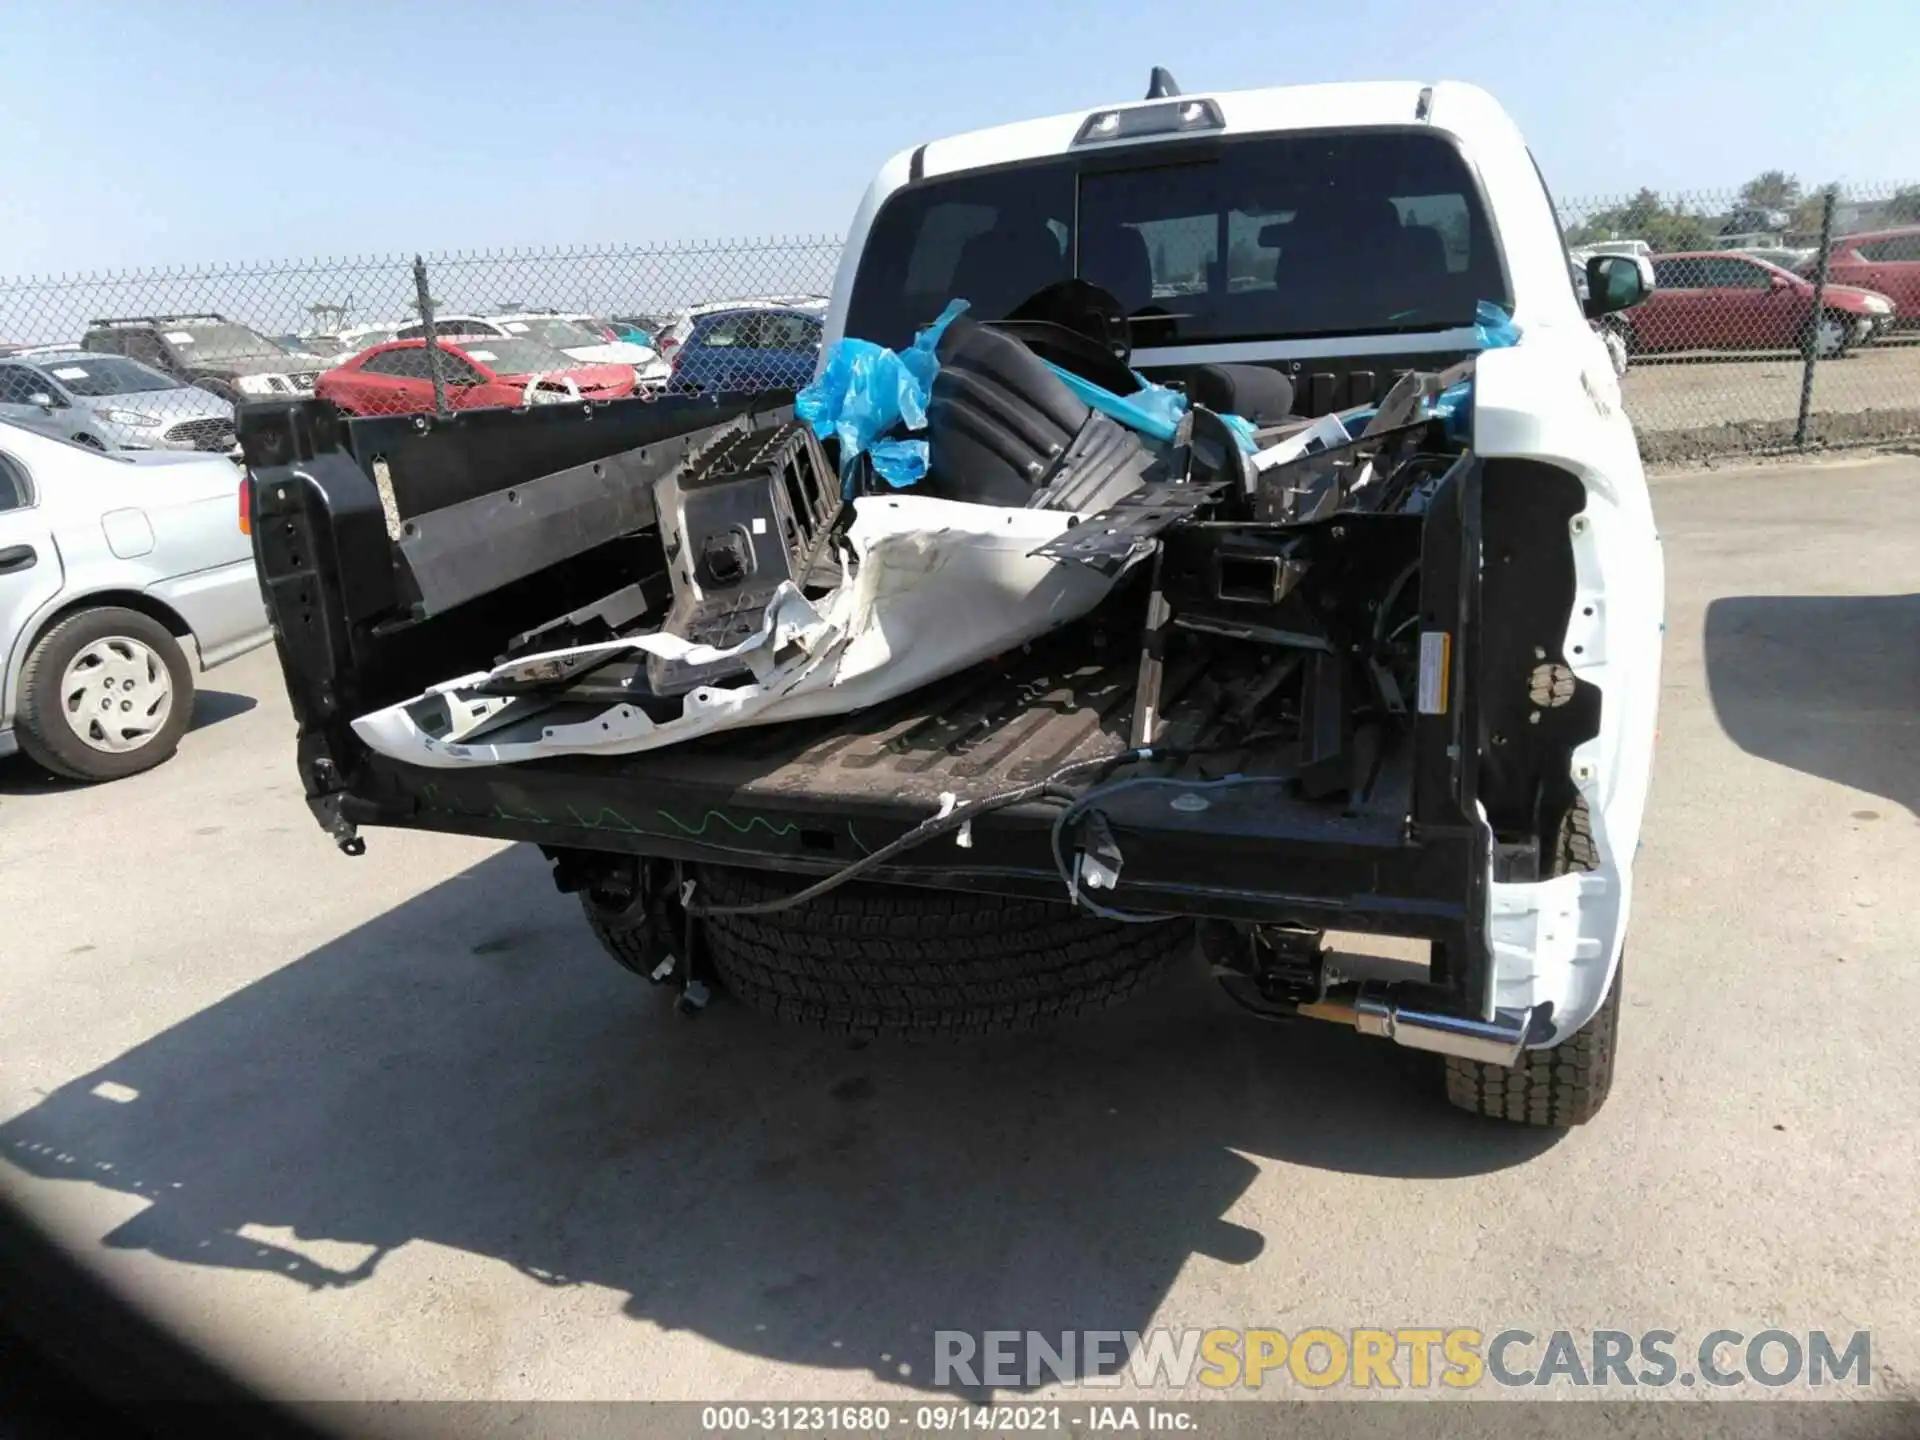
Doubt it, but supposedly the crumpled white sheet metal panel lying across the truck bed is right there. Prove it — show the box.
[353,495,1114,768]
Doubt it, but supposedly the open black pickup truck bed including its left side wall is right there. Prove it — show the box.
[240,389,1582,1006]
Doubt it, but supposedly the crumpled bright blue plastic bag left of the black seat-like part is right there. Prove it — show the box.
[793,300,966,486]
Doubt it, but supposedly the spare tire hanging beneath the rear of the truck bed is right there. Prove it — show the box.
[691,866,1194,1035]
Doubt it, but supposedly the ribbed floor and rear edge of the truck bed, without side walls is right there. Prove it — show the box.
[344,591,1443,941]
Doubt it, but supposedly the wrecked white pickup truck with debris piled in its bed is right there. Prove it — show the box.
[240,71,1663,1125]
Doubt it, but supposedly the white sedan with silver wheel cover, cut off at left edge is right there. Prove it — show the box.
[0,422,271,780]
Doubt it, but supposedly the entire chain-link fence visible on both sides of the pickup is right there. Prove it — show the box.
[0,175,1920,463]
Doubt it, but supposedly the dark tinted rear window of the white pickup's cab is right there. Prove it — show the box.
[847,129,1511,348]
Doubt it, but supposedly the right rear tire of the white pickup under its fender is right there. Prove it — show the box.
[1446,797,1626,1129]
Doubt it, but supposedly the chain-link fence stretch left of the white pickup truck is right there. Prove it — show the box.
[0,236,841,451]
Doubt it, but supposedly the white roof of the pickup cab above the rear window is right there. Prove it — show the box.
[906,81,1513,177]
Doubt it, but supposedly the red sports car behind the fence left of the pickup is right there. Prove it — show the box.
[313,336,634,415]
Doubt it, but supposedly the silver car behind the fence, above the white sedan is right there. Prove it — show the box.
[0,349,238,455]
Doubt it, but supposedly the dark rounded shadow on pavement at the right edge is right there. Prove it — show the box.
[1705,595,1920,810]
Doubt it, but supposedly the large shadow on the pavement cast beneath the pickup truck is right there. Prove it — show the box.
[0,841,1559,1384]
